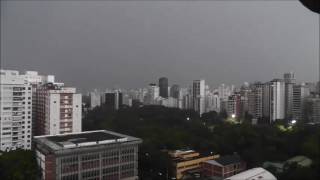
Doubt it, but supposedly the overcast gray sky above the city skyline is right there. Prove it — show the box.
[1,1,319,90]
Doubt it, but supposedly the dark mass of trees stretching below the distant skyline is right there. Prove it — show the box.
[83,106,320,180]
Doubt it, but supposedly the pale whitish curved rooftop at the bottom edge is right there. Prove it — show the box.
[225,167,277,180]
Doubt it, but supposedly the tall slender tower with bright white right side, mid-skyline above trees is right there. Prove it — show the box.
[192,80,205,115]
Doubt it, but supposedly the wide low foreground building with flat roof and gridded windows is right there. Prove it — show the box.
[34,130,142,180]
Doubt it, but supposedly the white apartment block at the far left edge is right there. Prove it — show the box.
[0,70,32,151]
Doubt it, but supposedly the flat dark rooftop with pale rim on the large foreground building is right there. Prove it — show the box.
[34,130,141,151]
